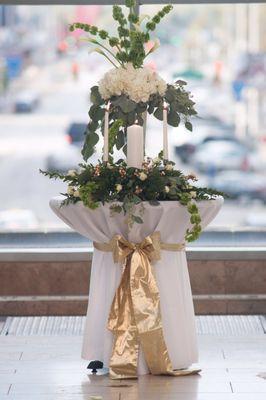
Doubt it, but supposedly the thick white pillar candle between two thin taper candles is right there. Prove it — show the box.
[127,125,144,168]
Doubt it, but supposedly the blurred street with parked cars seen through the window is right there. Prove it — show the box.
[0,4,266,231]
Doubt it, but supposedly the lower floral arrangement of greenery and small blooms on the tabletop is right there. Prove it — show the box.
[41,155,221,242]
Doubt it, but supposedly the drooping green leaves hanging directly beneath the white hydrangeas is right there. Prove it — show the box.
[82,76,197,161]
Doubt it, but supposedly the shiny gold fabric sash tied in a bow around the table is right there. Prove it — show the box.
[94,232,198,379]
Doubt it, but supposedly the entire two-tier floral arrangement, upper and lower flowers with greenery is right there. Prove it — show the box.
[40,0,222,242]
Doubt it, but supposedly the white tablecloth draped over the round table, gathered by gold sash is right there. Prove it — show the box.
[50,197,223,375]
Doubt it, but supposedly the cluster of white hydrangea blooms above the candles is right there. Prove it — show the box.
[99,63,167,103]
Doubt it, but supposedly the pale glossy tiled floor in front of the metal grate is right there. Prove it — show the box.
[0,318,266,400]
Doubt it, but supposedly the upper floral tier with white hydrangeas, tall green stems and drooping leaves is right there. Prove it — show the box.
[70,0,197,161]
